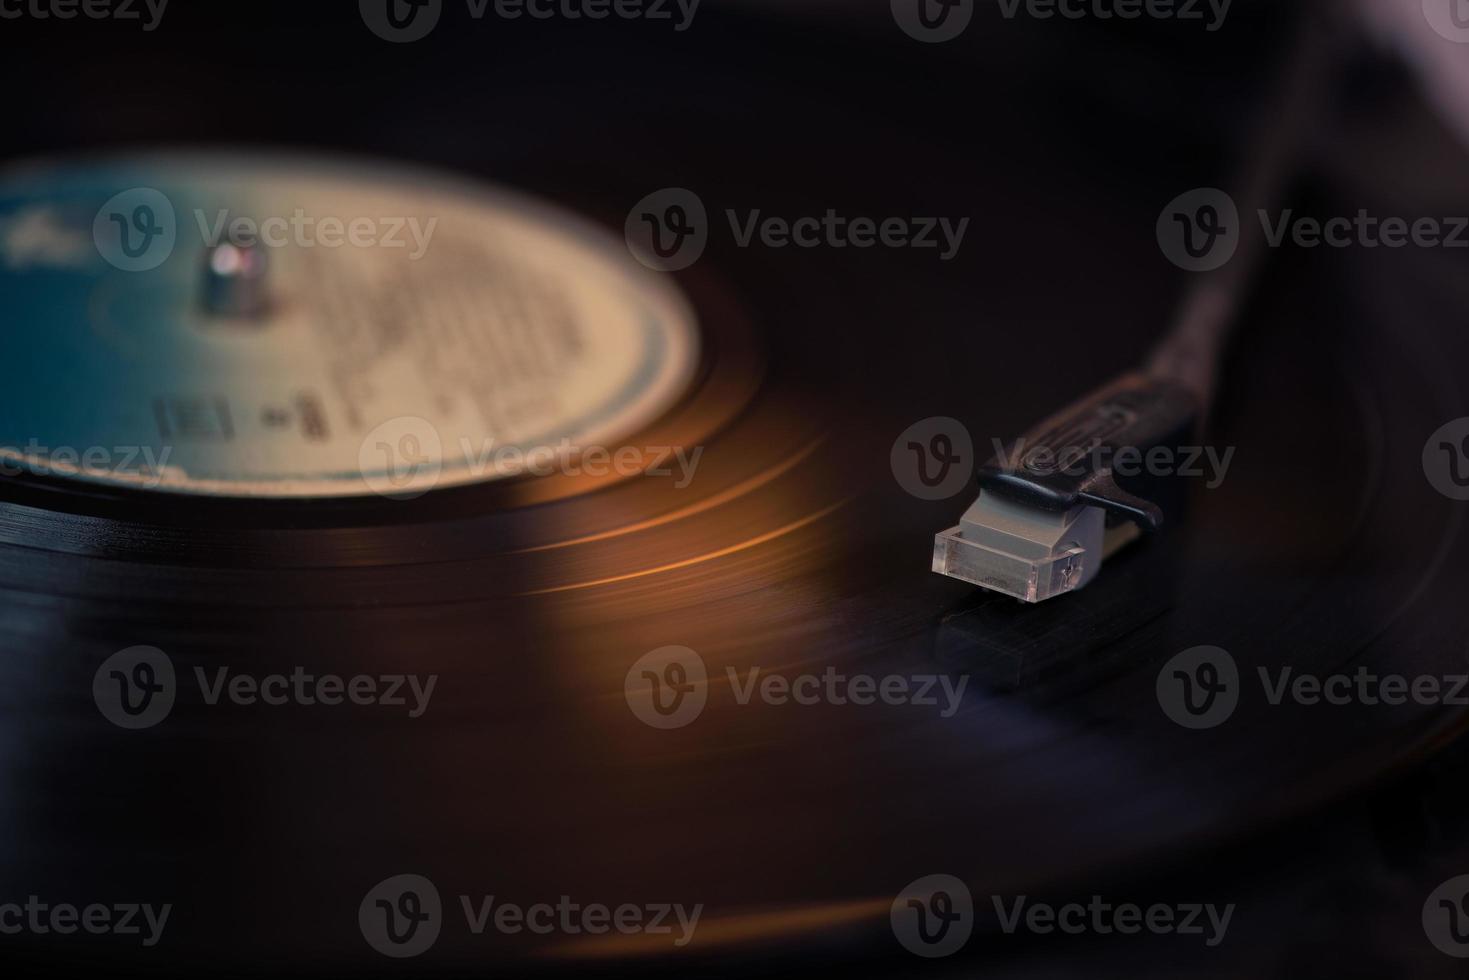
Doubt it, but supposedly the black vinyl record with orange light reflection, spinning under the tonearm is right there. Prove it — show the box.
[0,3,1469,976]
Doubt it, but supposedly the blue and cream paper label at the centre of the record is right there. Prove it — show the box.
[0,156,698,497]
